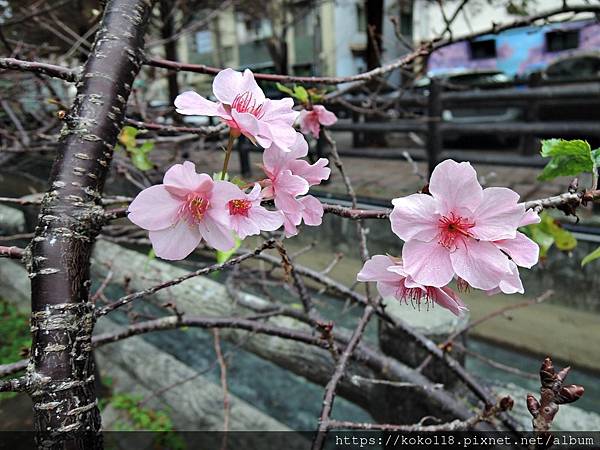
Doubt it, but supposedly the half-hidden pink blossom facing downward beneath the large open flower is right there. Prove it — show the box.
[356,255,468,316]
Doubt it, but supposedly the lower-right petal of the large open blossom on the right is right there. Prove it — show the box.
[450,239,510,290]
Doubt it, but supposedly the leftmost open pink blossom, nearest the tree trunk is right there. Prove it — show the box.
[128,161,240,260]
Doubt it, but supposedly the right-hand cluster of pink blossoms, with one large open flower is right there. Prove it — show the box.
[357,160,540,315]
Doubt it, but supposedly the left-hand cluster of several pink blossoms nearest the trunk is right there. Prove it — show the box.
[128,69,335,260]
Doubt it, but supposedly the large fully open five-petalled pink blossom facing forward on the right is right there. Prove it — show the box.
[390,160,525,290]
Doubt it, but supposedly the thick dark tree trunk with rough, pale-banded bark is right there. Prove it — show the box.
[26,0,152,449]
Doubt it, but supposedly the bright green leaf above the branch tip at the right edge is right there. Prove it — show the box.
[538,139,595,181]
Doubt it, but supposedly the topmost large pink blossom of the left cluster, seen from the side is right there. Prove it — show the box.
[175,69,299,149]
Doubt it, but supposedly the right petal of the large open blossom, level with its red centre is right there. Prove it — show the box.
[469,187,525,241]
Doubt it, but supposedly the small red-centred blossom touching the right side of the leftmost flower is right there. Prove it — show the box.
[227,183,283,239]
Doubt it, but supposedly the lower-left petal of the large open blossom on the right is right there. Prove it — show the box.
[402,240,454,287]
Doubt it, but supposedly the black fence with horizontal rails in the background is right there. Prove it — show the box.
[238,79,600,175]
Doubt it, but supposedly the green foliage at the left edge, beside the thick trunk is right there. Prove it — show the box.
[0,299,31,400]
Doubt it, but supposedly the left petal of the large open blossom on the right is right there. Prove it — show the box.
[390,194,440,241]
